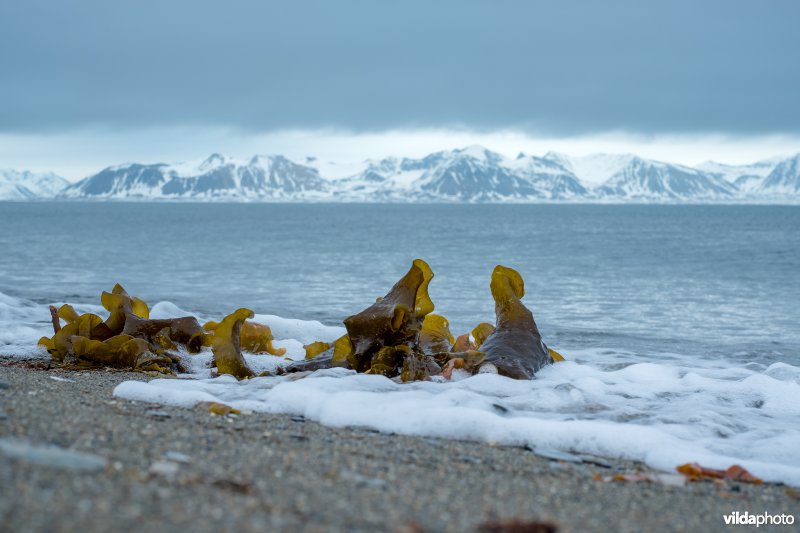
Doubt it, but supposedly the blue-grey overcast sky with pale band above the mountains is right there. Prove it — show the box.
[0,0,800,177]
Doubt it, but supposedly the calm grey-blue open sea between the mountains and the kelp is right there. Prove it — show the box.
[0,202,800,364]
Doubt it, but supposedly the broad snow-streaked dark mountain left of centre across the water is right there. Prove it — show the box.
[59,154,328,200]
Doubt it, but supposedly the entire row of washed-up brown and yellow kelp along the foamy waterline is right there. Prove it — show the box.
[39,259,563,382]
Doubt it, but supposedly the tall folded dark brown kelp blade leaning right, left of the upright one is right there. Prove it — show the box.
[344,259,433,372]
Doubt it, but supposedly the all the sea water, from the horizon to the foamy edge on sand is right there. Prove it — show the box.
[0,203,800,484]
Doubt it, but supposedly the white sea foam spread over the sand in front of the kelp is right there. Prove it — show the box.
[114,351,800,485]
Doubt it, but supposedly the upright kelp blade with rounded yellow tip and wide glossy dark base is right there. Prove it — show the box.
[480,265,553,379]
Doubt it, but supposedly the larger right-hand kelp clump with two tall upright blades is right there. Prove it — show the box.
[279,259,563,382]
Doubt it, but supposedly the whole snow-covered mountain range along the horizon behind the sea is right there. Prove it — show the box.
[0,146,800,203]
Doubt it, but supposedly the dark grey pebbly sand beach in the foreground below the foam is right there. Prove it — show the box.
[0,358,800,532]
